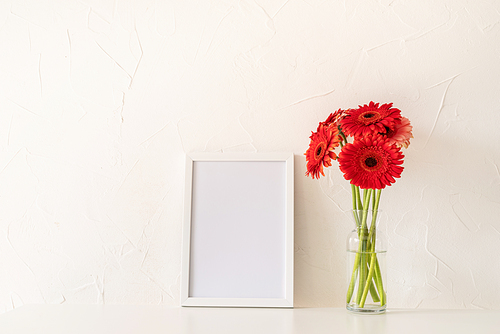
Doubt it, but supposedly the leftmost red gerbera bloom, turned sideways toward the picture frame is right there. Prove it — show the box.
[304,124,340,179]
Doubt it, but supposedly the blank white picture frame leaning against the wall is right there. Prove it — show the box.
[181,153,294,308]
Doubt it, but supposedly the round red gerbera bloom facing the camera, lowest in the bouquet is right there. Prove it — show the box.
[338,136,404,189]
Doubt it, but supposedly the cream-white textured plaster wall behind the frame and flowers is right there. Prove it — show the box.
[0,0,500,312]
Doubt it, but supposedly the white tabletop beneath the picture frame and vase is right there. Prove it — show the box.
[0,304,500,334]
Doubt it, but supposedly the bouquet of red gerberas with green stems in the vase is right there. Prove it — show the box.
[305,102,413,308]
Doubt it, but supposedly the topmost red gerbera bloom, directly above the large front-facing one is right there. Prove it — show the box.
[340,101,401,137]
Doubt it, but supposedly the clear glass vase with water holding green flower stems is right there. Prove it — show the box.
[346,210,387,314]
